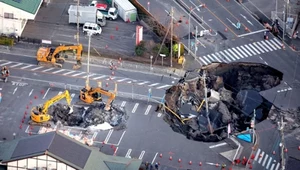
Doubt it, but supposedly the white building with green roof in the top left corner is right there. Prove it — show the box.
[0,0,42,36]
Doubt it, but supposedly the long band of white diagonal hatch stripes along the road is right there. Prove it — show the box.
[0,60,172,89]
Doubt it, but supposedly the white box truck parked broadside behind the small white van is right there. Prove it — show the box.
[68,5,106,27]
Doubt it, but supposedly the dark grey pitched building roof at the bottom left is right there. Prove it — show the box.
[0,132,142,170]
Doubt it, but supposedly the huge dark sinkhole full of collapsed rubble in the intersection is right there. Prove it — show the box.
[162,63,283,142]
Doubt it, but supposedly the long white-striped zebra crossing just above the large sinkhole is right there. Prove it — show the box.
[199,38,282,65]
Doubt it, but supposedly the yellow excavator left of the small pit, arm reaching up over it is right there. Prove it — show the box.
[28,90,73,127]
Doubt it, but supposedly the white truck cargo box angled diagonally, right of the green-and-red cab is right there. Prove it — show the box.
[113,0,137,22]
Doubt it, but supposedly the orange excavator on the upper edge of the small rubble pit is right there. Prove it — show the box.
[79,81,117,111]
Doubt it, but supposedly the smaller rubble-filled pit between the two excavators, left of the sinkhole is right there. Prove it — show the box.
[48,102,128,129]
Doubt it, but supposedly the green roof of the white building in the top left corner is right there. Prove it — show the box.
[0,0,42,14]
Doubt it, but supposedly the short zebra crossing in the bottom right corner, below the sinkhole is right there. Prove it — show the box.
[254,149,280,170]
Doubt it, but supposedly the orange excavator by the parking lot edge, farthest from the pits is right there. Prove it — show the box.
[36,44,83,70]
